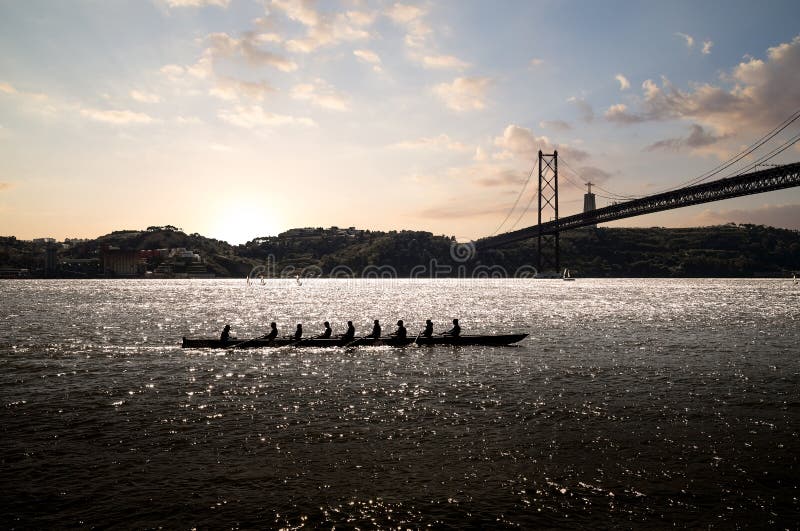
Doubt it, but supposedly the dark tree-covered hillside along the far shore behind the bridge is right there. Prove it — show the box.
[0,224,800,278]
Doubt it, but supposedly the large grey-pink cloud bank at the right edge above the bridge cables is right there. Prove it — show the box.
[606,36,800,135]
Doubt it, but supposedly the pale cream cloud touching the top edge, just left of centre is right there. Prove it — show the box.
[270,0,375,53]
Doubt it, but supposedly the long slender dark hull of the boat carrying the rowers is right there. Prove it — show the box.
[181,334,528,348]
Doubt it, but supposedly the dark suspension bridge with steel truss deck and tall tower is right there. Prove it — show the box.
[475,151,800,271]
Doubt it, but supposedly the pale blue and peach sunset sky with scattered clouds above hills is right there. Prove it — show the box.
[0,0,800,243]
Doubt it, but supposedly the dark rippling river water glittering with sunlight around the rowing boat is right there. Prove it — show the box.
[0,279,800,529]
